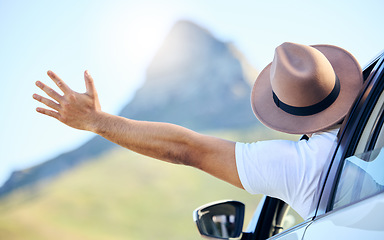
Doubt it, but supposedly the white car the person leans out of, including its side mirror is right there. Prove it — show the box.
[193,51,384,240]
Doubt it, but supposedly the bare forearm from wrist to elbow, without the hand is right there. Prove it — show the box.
[91,112,207,166]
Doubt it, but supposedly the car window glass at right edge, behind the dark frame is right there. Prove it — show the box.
[333,81,384,209]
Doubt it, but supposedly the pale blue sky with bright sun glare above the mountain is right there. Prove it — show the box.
[0,0,384,184]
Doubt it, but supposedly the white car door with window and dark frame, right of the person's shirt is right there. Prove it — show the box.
[303,50,384,240]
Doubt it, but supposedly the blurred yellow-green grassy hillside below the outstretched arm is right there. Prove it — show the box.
[0,126,296,240]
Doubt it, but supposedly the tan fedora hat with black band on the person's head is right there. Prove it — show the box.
[251,43,363,134]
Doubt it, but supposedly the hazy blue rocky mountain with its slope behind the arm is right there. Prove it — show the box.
[0,21,258,196]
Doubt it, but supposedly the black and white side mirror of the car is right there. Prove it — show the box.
[193,200,245,239]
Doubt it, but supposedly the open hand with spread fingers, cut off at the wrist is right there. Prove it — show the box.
[33,71,101,131]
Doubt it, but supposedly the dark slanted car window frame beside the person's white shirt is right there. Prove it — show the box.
[315,51,384,218]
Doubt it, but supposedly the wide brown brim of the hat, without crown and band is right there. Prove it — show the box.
[251,45,363,134]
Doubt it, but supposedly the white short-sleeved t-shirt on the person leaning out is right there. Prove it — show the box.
[236,129,338,219]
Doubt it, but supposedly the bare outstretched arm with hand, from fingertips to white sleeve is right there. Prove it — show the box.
[33,71,242,188]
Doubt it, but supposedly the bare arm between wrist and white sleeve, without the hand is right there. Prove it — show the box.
[92,113,242,188]
